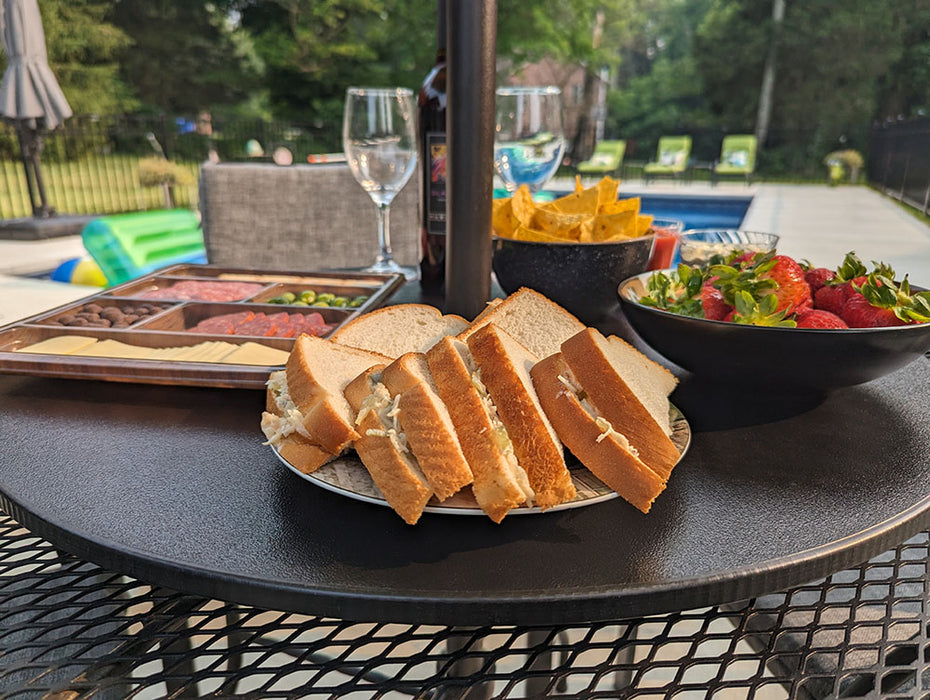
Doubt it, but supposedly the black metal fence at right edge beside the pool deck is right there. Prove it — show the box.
[868,117,930,214]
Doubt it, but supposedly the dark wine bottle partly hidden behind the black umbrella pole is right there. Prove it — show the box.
[417,0,446,291]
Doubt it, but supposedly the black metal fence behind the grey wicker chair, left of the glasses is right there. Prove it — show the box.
[0,114,340,219]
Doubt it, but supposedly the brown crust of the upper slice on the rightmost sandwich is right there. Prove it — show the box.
[550,328,679,479]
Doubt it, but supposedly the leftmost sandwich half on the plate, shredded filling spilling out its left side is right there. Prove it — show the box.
[262,335,390,464]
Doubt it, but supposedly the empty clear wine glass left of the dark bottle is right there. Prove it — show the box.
[342,87,417,279]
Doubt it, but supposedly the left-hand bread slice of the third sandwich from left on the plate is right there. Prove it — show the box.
[426,336,533,523]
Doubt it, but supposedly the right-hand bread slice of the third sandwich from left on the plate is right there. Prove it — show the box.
[468,323,575,510]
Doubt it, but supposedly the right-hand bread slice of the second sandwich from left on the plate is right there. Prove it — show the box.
[381,352,472,501]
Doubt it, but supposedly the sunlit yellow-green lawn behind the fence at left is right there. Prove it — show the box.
[0,155,200,219]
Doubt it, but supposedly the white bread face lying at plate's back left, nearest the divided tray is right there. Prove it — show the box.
[330,304,468,359]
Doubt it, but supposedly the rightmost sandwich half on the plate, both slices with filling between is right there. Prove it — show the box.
[530,328,679,513]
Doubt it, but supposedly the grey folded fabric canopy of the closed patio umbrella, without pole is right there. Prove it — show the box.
[0,0,71,129]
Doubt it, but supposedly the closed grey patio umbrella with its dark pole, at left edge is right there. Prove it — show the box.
[0,0,71,217]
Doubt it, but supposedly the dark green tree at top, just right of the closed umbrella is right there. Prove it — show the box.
[110,0,261,113]
